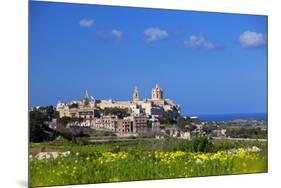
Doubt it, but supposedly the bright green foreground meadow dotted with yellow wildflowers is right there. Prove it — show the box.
[30,138,267,187]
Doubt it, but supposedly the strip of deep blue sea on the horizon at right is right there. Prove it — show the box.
[189,113,267,121]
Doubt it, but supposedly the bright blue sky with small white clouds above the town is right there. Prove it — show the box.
[29,2,267,115]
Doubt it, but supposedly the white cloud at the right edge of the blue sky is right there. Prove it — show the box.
[239,31,267,48]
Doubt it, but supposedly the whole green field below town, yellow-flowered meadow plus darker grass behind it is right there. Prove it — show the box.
[29,139,267,187]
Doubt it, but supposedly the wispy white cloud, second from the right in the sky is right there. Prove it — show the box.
[184,35,219,49]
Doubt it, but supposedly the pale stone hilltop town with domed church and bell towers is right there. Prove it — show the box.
[53,84,180,133]
